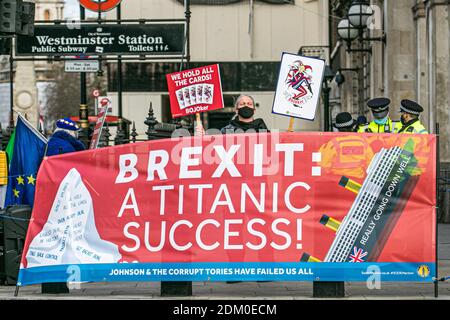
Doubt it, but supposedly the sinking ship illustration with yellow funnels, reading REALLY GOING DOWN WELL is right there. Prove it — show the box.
[301,139,420,262]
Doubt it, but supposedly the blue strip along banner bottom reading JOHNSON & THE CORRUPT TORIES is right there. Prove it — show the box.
[17,262,436,286]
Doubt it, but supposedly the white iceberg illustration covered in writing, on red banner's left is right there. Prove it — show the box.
[26,168,121,268]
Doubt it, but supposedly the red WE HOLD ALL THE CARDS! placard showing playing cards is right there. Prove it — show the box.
[166,64,224,118]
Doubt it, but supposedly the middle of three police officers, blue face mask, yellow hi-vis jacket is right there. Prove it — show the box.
[358,98,401,133]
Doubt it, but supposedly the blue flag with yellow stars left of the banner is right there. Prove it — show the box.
[5,115,47,207]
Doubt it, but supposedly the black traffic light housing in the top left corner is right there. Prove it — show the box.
[0,0,35,36]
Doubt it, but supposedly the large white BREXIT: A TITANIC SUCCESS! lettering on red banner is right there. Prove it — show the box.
[115,138,311,252]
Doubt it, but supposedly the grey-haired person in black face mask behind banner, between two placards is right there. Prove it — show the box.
[220,95,269,134]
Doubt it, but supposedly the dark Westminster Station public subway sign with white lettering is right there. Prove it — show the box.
[16,23,185,56]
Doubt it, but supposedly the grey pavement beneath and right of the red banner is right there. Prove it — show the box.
[0,224,450,300]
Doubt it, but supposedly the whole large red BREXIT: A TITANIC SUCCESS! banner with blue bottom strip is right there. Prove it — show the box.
[18,132,436,286]
